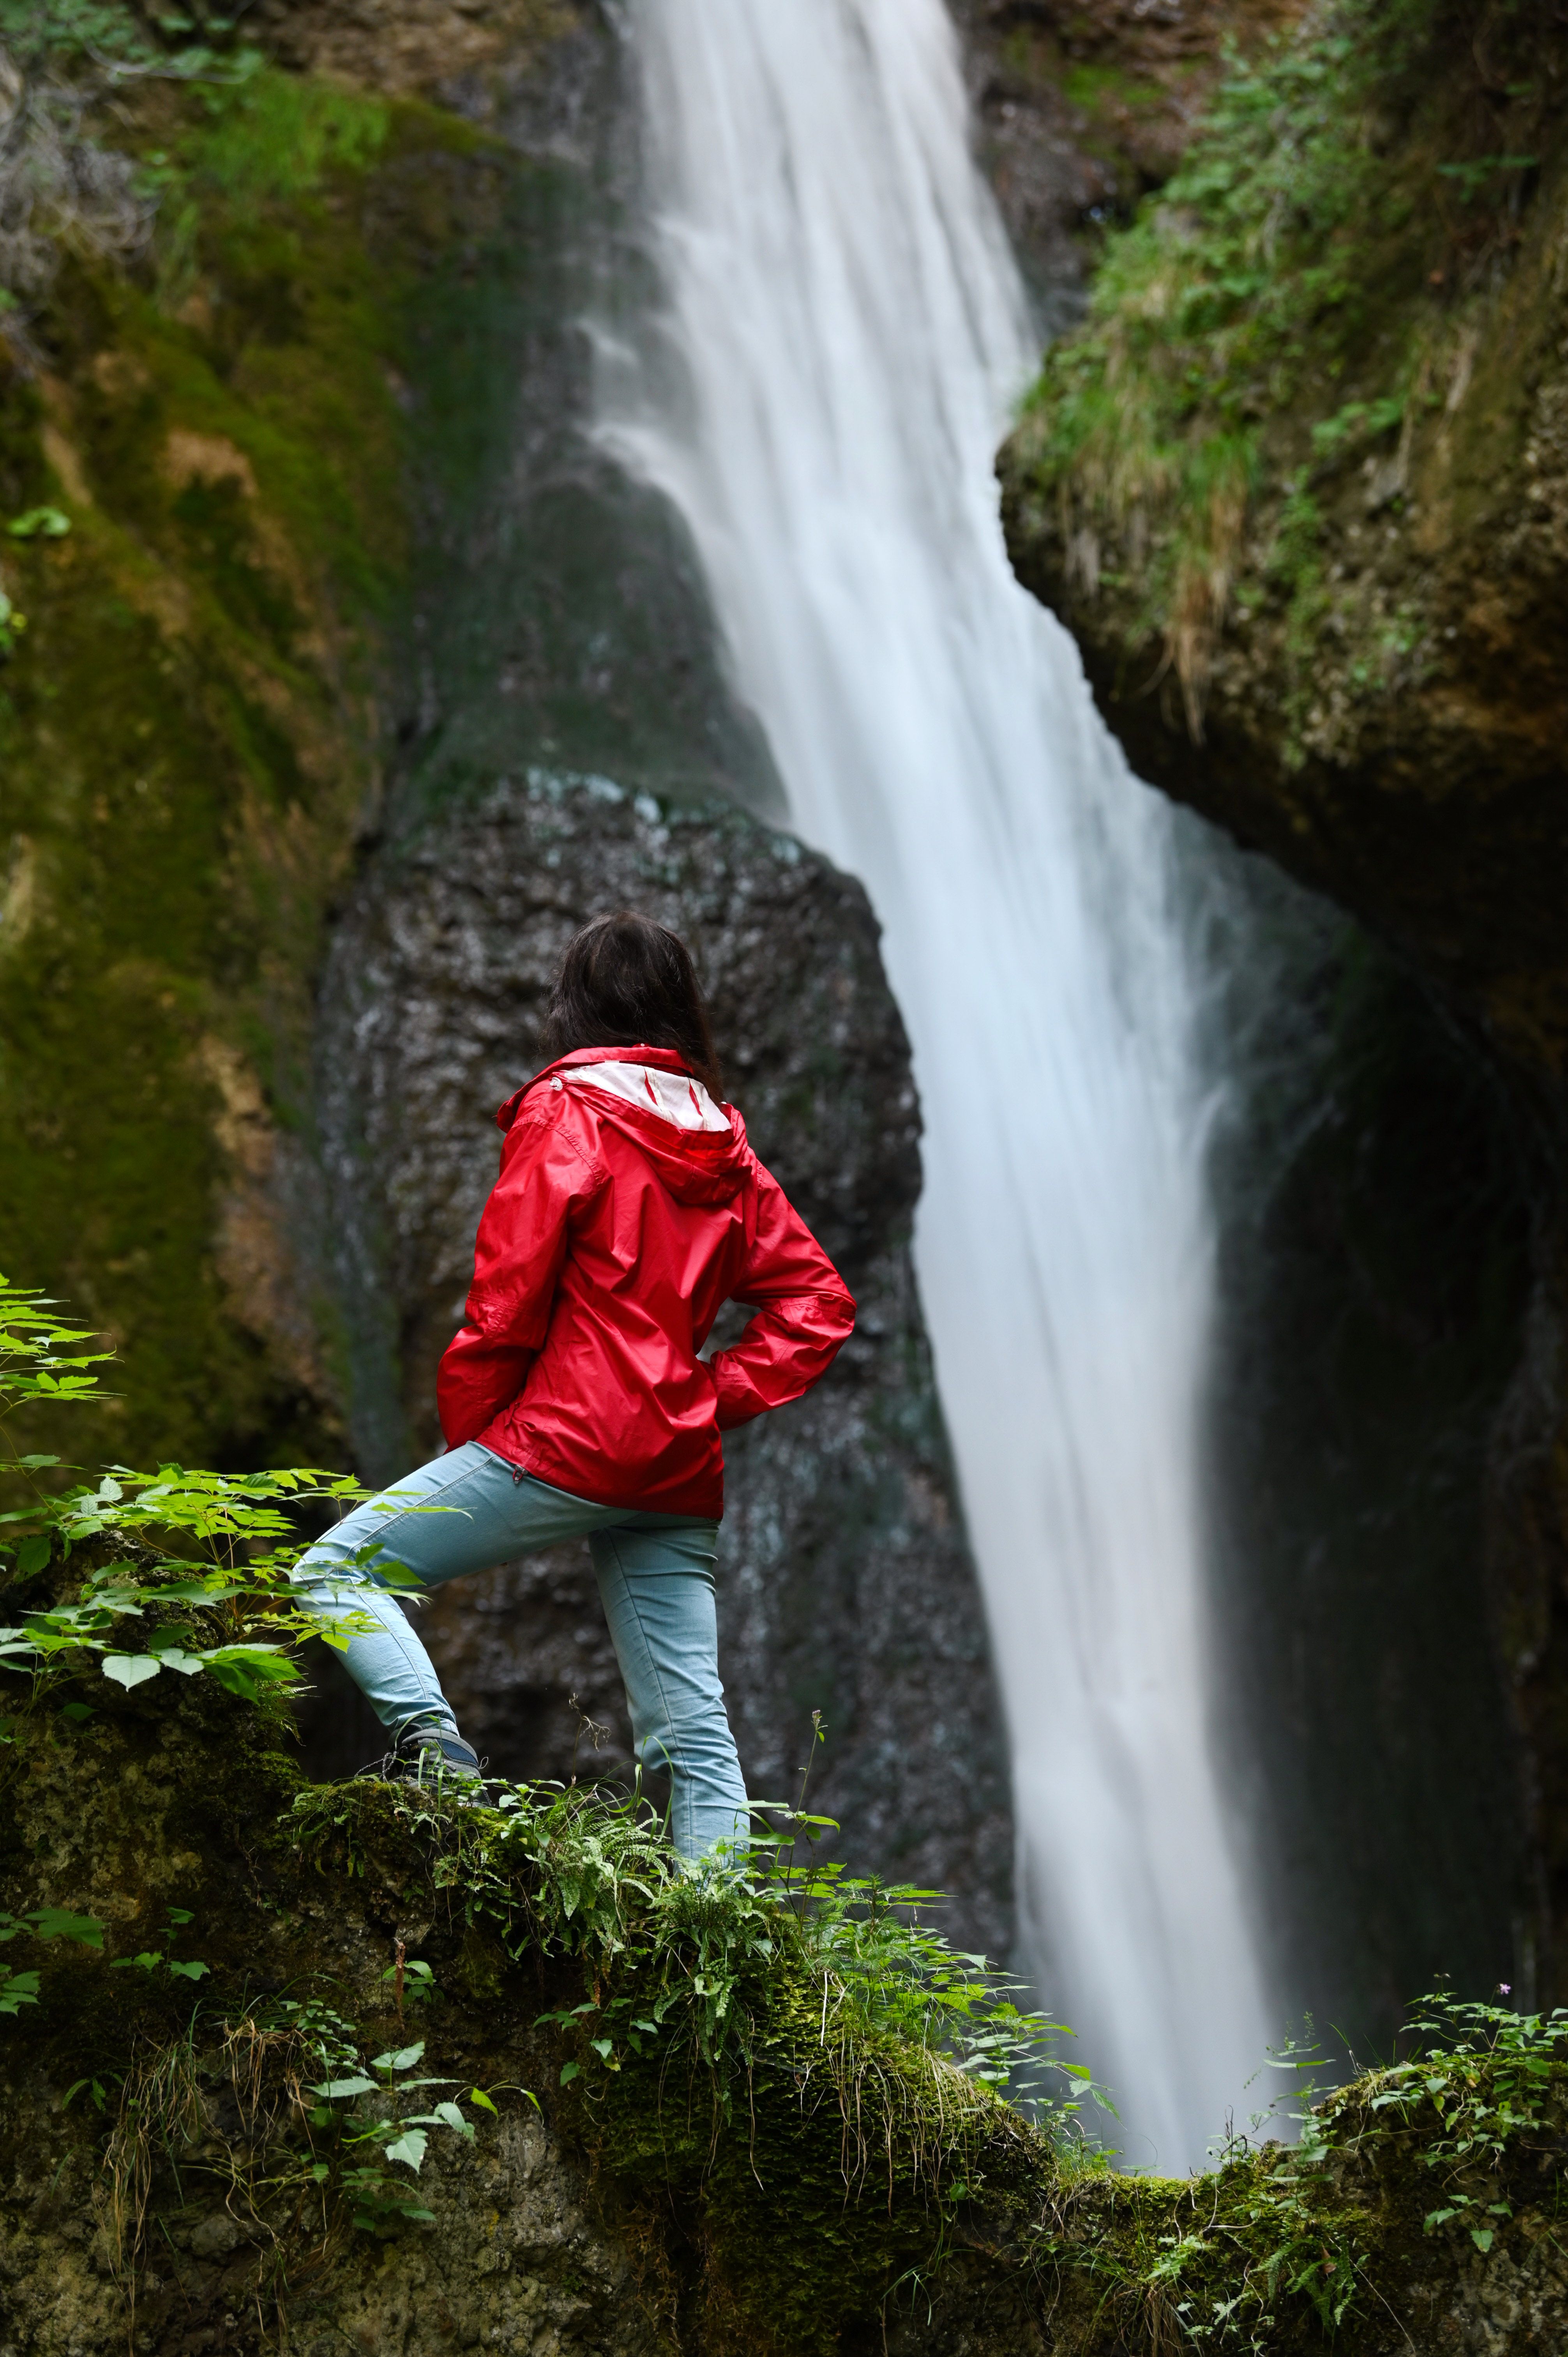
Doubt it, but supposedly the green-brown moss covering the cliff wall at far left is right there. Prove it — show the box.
[0,71,556,1464]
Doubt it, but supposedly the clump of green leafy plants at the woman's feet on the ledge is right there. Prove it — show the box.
[295,1784,1113,2145]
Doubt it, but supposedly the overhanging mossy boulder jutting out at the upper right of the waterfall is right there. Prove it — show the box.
[998,0,1568,1079]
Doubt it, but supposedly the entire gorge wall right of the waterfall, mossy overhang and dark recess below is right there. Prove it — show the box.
[1000,5,1568,2001]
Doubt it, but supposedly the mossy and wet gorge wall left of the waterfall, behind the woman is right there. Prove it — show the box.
[0,5,1012,1952]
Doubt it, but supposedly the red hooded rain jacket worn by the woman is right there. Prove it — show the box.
[436,1046,856,1520]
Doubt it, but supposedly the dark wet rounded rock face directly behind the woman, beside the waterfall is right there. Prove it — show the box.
[309,773,1012,1954]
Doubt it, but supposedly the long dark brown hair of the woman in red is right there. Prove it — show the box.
[542,907,724,1101]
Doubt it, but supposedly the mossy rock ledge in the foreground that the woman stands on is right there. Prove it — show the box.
[0,1556,1568,2357]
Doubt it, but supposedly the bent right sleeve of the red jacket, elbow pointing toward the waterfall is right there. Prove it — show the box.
[710,1162,856,1433]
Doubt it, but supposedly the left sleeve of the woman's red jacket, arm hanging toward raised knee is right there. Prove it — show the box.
[436,1113,608,1450]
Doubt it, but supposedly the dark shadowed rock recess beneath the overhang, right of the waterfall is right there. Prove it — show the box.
[1205,844,1540,2055]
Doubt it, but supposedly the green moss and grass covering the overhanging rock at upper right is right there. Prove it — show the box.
[1009,0,1549,740]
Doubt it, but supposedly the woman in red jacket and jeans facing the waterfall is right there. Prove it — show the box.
[295,910,854,1860]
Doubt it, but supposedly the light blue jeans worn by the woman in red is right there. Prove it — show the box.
[295,1440,750,1864]
